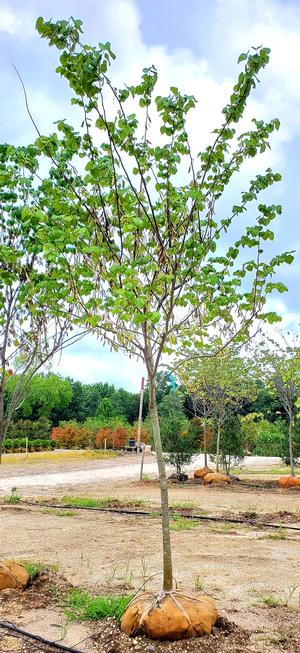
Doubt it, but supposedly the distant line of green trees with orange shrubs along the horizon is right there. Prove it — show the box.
[1,364,300,473]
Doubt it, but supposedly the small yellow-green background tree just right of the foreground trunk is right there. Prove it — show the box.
[179,344,256,471]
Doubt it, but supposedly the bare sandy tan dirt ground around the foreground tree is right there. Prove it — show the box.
[0,457,300,653]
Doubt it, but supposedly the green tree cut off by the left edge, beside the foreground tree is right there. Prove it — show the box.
[0,145,83,462]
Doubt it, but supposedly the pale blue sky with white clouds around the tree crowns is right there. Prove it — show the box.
[0,0,300,391]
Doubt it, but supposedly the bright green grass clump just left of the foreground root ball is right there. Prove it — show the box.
[65,589,133,621]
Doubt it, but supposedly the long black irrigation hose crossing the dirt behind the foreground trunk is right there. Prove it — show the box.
[20,501,300,532]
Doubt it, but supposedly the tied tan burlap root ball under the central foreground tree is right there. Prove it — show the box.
[121,590,218,641]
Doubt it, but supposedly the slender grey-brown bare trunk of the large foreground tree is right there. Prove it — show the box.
[149,375,173,591]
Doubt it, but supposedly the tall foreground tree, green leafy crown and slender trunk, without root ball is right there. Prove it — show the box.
[19,18,292,624]
